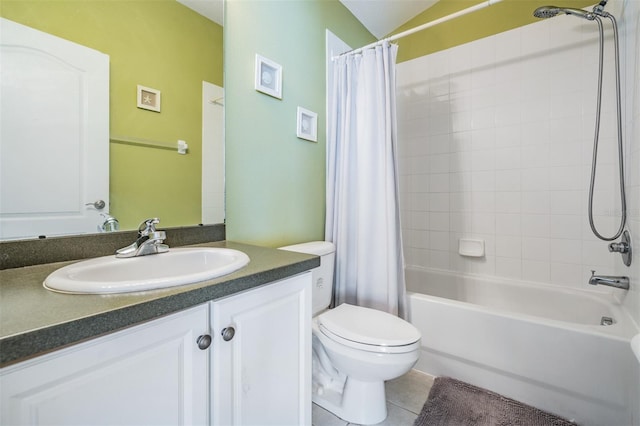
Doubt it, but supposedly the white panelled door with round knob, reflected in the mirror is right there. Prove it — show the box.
[0,18,109,239]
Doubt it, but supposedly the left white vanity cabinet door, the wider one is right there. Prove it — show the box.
[0,304,209,426]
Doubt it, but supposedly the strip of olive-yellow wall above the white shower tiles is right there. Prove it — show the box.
[391,0,594,62]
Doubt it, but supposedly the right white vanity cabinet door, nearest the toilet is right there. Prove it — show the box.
[211,273,311,426]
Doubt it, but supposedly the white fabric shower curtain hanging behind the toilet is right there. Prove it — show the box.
[326,42,406,318]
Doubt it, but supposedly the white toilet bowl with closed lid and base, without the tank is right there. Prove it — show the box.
[312,304,420,425]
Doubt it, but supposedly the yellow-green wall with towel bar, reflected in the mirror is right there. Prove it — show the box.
[0,0,223,229]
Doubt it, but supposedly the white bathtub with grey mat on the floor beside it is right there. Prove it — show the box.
[406,268,640,426]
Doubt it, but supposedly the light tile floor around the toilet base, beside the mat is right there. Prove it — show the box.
[312,370,435,426]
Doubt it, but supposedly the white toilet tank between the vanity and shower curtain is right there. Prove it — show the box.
[280,241,336,316]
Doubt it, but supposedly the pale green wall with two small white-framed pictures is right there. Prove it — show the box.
[224,0,375,247]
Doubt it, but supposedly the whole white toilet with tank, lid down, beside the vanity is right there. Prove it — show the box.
[281,241,421,425]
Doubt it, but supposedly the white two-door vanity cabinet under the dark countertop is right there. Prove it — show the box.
[0,272,311,426]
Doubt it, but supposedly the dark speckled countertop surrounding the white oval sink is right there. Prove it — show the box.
[0,241,320,367]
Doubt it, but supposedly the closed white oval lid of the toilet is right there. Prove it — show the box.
[318,303,421,347]
